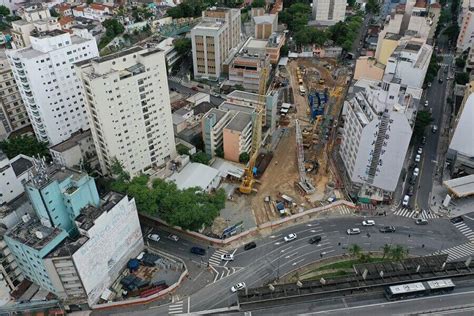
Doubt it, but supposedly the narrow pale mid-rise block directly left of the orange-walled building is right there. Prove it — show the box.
[201,109,232,157]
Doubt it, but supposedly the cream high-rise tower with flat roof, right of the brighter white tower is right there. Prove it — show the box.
[78,46,176,175]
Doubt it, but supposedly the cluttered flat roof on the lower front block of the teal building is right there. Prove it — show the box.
[7,218,64,250]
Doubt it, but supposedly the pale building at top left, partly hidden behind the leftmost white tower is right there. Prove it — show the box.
[11,3,61,48]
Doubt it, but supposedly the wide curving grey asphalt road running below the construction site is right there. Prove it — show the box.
[110,215,466,315]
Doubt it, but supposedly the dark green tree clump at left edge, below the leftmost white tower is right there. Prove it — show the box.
[0,135,51,160]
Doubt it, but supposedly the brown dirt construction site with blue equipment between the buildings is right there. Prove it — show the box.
[241,58,349,225]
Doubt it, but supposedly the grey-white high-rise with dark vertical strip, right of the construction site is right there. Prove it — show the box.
[340,80,422,202]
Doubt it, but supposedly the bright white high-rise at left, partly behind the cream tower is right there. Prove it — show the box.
[7,30,99,145]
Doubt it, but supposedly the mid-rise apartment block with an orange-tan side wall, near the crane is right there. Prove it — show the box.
[223,112,252,162]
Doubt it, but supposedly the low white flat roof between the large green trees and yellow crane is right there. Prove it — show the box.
[168,162,219,190]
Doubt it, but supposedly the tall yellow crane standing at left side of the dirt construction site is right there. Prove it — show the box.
[239,68,268,194]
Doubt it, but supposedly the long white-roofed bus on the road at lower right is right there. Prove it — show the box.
[384,279,455,301]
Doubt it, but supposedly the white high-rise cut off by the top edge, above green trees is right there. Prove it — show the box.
[313,0,346,25]
